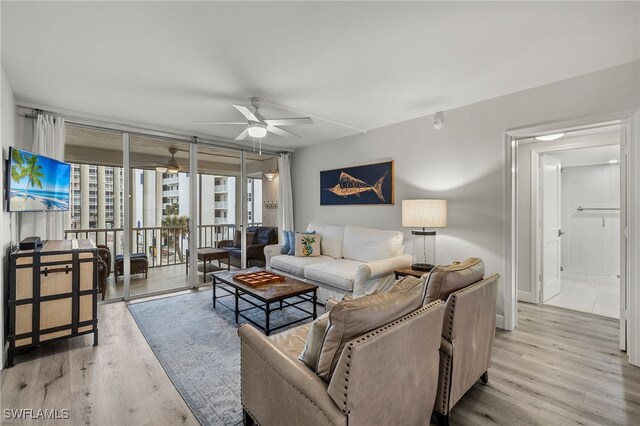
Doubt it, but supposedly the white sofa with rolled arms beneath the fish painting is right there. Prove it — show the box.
[264,223,411,303]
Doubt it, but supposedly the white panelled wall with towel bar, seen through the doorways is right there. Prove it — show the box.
[561,164,620,278]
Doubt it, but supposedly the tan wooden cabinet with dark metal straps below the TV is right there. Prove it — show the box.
[7,240,98,366]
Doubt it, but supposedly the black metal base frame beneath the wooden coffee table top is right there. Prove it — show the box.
[212,274,317,336]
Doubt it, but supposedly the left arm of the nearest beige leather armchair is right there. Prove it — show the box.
[238,324,347,425]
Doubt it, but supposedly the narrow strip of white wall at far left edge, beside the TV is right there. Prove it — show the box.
[0,65,18,369]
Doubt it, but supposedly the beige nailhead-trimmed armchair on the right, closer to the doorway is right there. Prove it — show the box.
[426,258,498,425]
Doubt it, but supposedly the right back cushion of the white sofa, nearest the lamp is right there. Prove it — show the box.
[342,225,404,262]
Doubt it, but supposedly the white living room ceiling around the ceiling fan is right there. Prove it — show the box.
[0,1,640,148]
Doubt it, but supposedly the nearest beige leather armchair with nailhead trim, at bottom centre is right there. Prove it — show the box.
[238,285,444,426]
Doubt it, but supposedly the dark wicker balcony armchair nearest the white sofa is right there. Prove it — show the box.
[217,226,278,268]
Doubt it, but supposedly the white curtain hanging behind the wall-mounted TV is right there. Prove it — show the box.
[20,114,65,240]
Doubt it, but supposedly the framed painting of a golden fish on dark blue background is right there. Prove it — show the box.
[320,161,393,206]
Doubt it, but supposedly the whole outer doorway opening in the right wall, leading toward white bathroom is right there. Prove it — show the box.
[515,124,627,349]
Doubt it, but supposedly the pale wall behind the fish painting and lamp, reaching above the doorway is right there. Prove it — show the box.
[292,61,640,320]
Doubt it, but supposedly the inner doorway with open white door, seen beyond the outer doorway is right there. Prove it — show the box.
[539,145,620,318]
